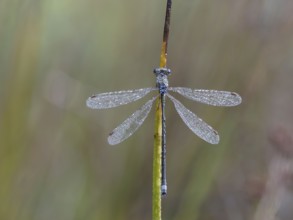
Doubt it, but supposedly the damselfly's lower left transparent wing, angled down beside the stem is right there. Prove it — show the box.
[108,96,158,145]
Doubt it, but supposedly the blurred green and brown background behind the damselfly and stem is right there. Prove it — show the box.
[0,0,293,220]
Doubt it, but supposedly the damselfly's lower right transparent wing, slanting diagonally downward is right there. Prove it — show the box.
[167,94,220,144]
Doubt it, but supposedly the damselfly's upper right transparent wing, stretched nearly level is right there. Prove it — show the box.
[169,87,242,106]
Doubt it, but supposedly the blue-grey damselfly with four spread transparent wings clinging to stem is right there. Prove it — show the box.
[86,68,241,195]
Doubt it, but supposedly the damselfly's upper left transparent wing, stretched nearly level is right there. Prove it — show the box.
[86,88,157,109]
